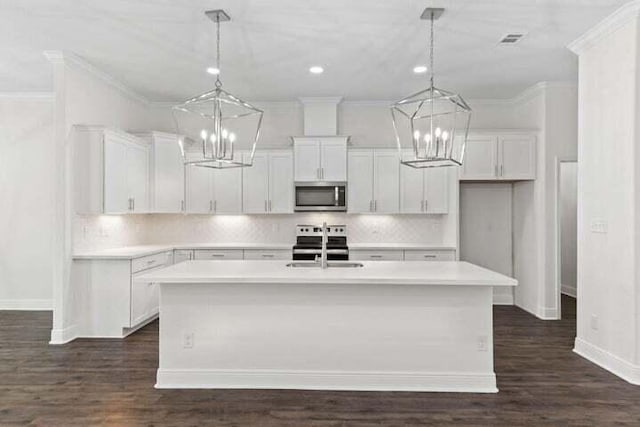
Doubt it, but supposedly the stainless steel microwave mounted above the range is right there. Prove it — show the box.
[294,182,347,212]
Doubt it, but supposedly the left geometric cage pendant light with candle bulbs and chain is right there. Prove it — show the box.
[172,9,264,169]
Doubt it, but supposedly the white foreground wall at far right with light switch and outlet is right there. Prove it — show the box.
[572,1,640,384]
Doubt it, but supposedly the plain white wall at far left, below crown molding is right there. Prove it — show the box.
[0,94,54,309]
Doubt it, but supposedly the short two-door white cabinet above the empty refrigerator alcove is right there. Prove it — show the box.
[460,132,536,181]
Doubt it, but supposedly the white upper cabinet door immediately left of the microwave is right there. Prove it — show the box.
[267,152,293,213]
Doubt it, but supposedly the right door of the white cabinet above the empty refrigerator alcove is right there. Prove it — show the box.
[498,135,536,179]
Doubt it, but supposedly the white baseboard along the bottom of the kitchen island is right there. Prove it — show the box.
[155,369,498,393]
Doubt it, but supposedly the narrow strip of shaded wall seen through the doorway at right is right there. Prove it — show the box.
[560,162,578,297]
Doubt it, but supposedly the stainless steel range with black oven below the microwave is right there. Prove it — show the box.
[293,225,349,261]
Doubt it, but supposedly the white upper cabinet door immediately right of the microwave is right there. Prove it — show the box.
[347,150,373,213]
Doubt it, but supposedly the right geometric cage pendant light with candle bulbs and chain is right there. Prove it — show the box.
[391,8,471,168]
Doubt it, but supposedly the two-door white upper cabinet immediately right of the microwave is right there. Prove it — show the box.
[347,150,400,213]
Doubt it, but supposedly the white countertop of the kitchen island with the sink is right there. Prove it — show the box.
[138,260,518,286]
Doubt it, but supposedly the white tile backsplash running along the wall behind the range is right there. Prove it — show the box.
[73,213,446,252]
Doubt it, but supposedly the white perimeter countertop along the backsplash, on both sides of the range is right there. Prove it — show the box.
[73,242,456,260]
